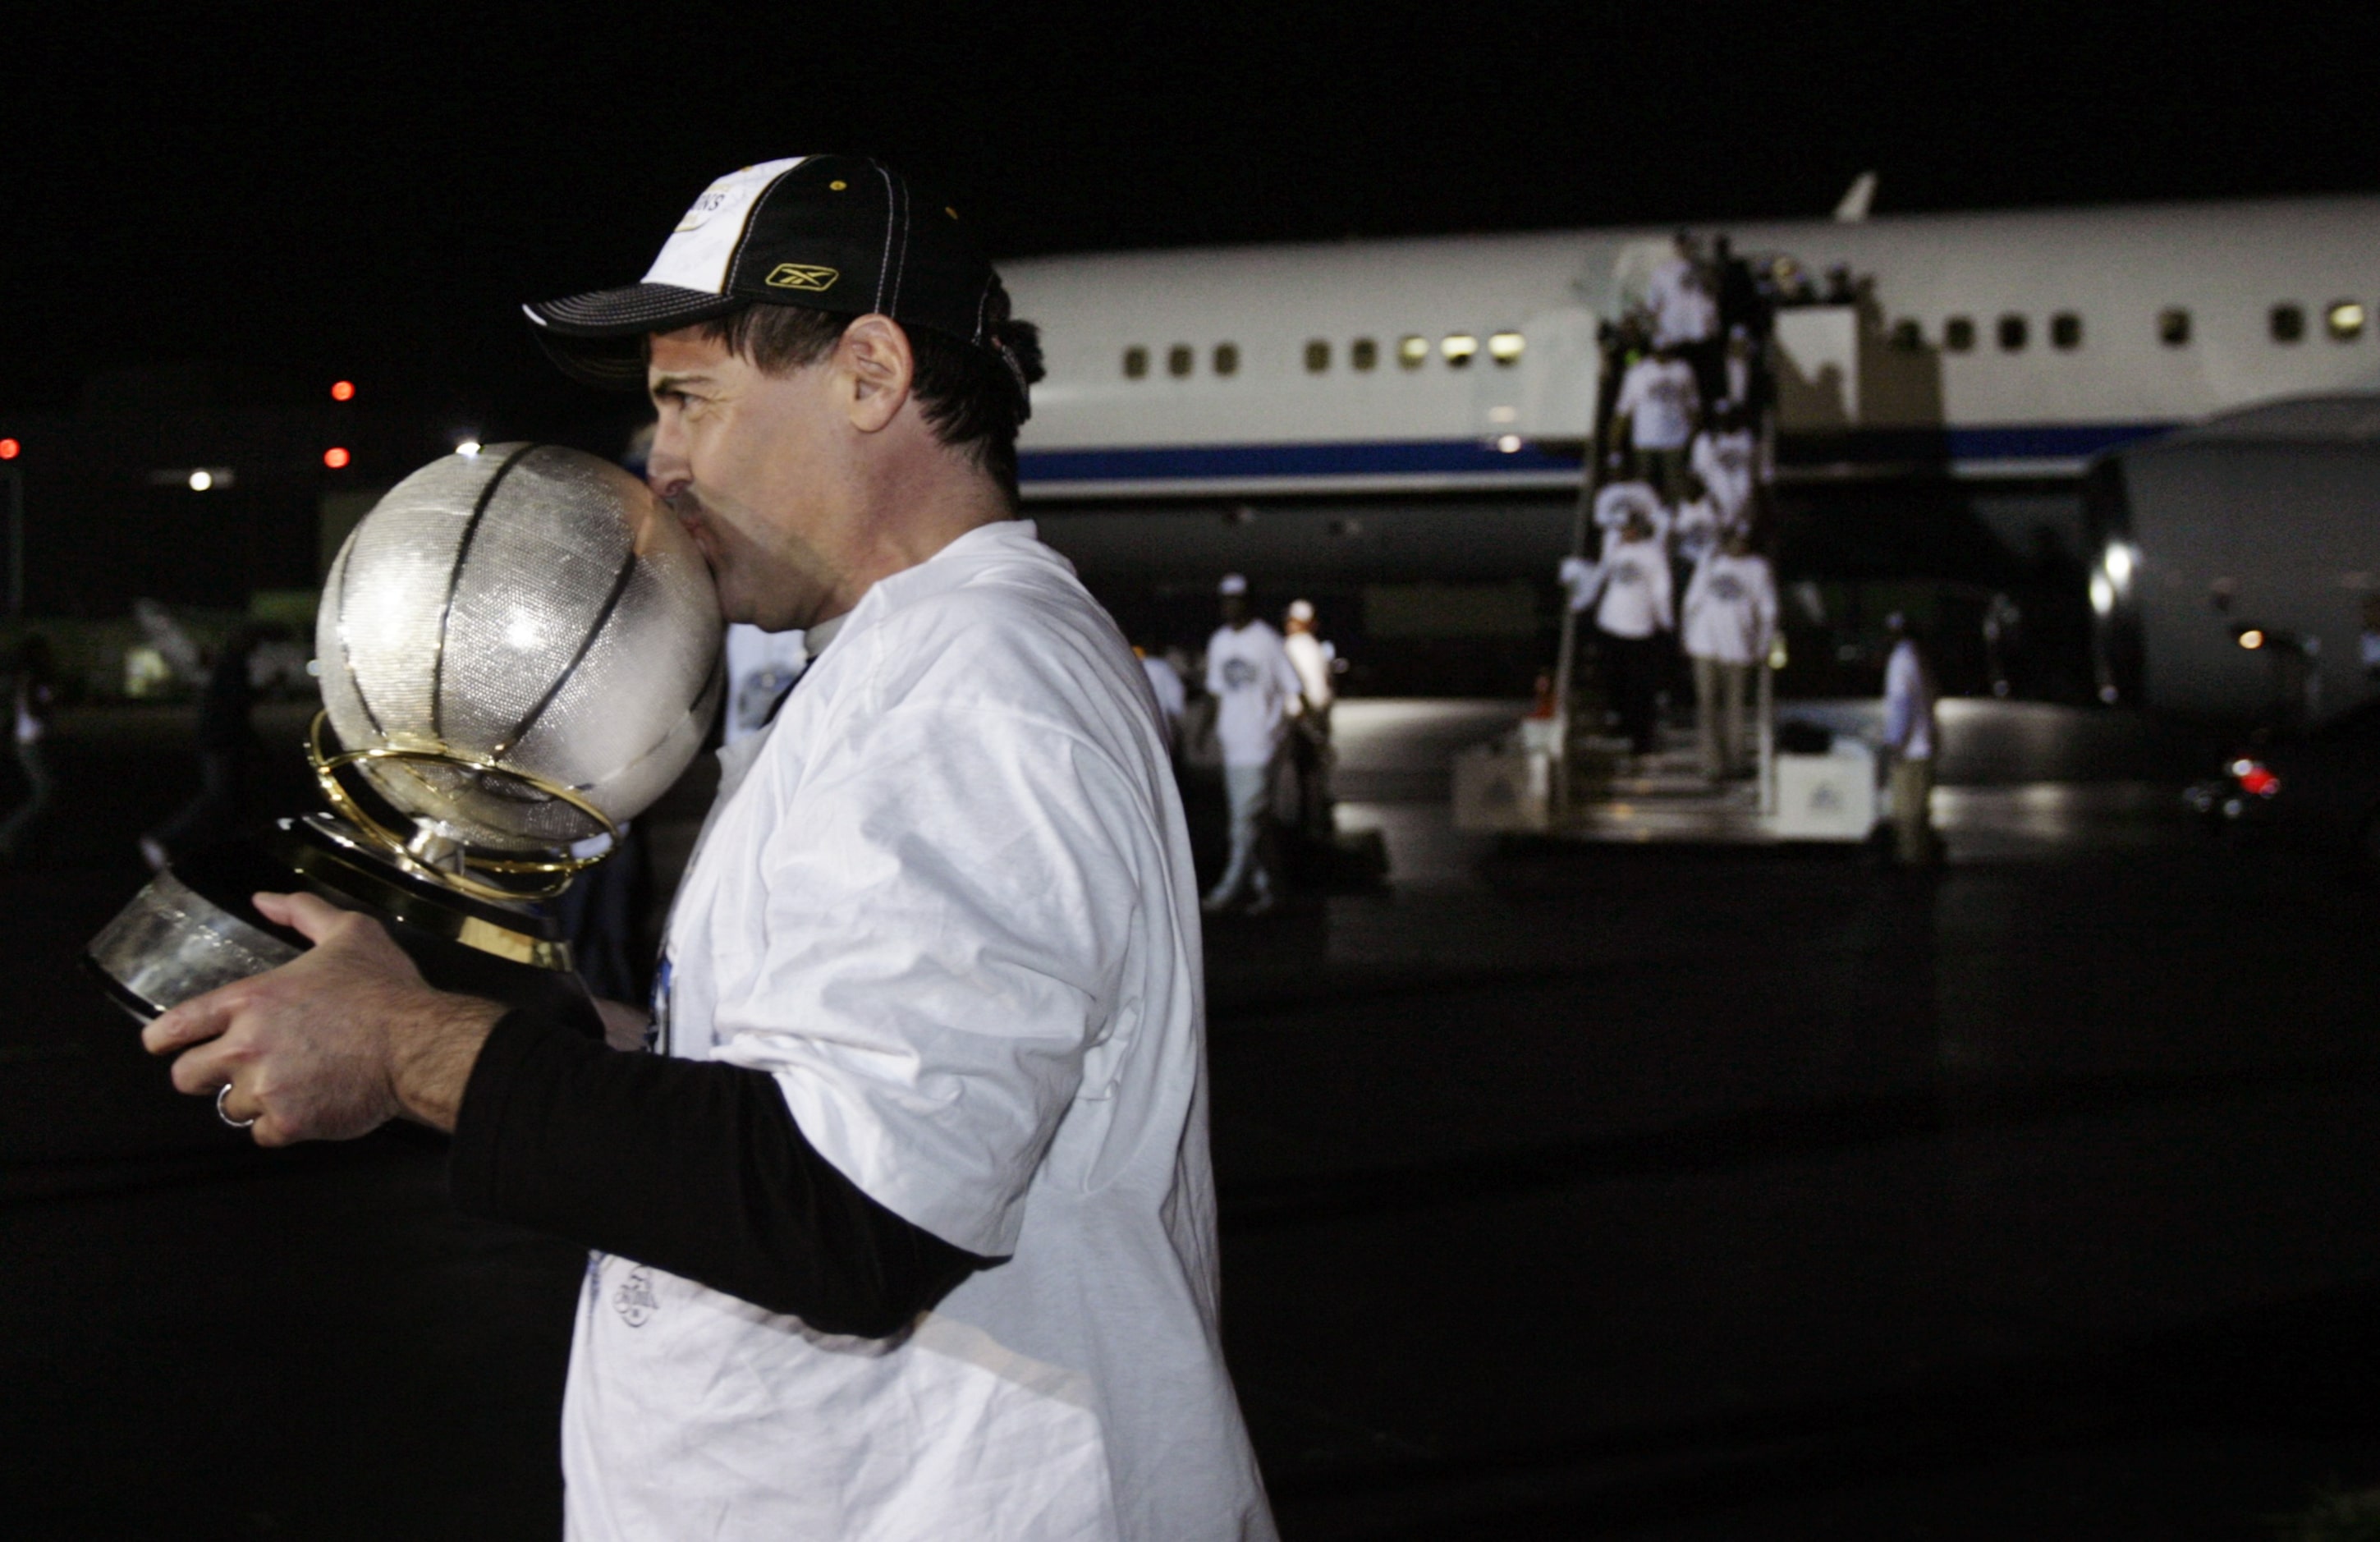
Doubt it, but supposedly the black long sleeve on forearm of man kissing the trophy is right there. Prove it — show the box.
[447,1009,997,1338]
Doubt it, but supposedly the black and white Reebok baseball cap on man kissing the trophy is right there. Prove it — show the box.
[521,154,1024,390]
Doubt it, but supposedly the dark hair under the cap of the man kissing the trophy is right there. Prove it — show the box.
[699,298,1043,503]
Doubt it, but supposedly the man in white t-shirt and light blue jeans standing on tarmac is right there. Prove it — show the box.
[1202,573,1305,916]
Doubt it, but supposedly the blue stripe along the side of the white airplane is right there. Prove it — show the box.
[1016,424,2173,483]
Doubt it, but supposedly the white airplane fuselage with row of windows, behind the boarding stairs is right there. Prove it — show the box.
[1007,198,2380,503]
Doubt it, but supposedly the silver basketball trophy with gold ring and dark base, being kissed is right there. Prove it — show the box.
[85,445,721,1033]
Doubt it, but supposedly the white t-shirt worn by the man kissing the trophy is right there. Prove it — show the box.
[562,521,1273,1542]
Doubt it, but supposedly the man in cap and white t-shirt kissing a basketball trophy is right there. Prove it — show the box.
[145,154,1273,1542]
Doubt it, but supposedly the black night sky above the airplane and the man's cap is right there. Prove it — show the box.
[0,2,2380,431]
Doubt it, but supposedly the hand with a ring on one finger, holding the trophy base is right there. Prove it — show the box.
[140,895,505,1147]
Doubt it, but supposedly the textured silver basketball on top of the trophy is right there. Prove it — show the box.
[317,445,721,852]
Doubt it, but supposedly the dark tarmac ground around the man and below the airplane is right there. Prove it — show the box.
[0,702,2380,1542]
